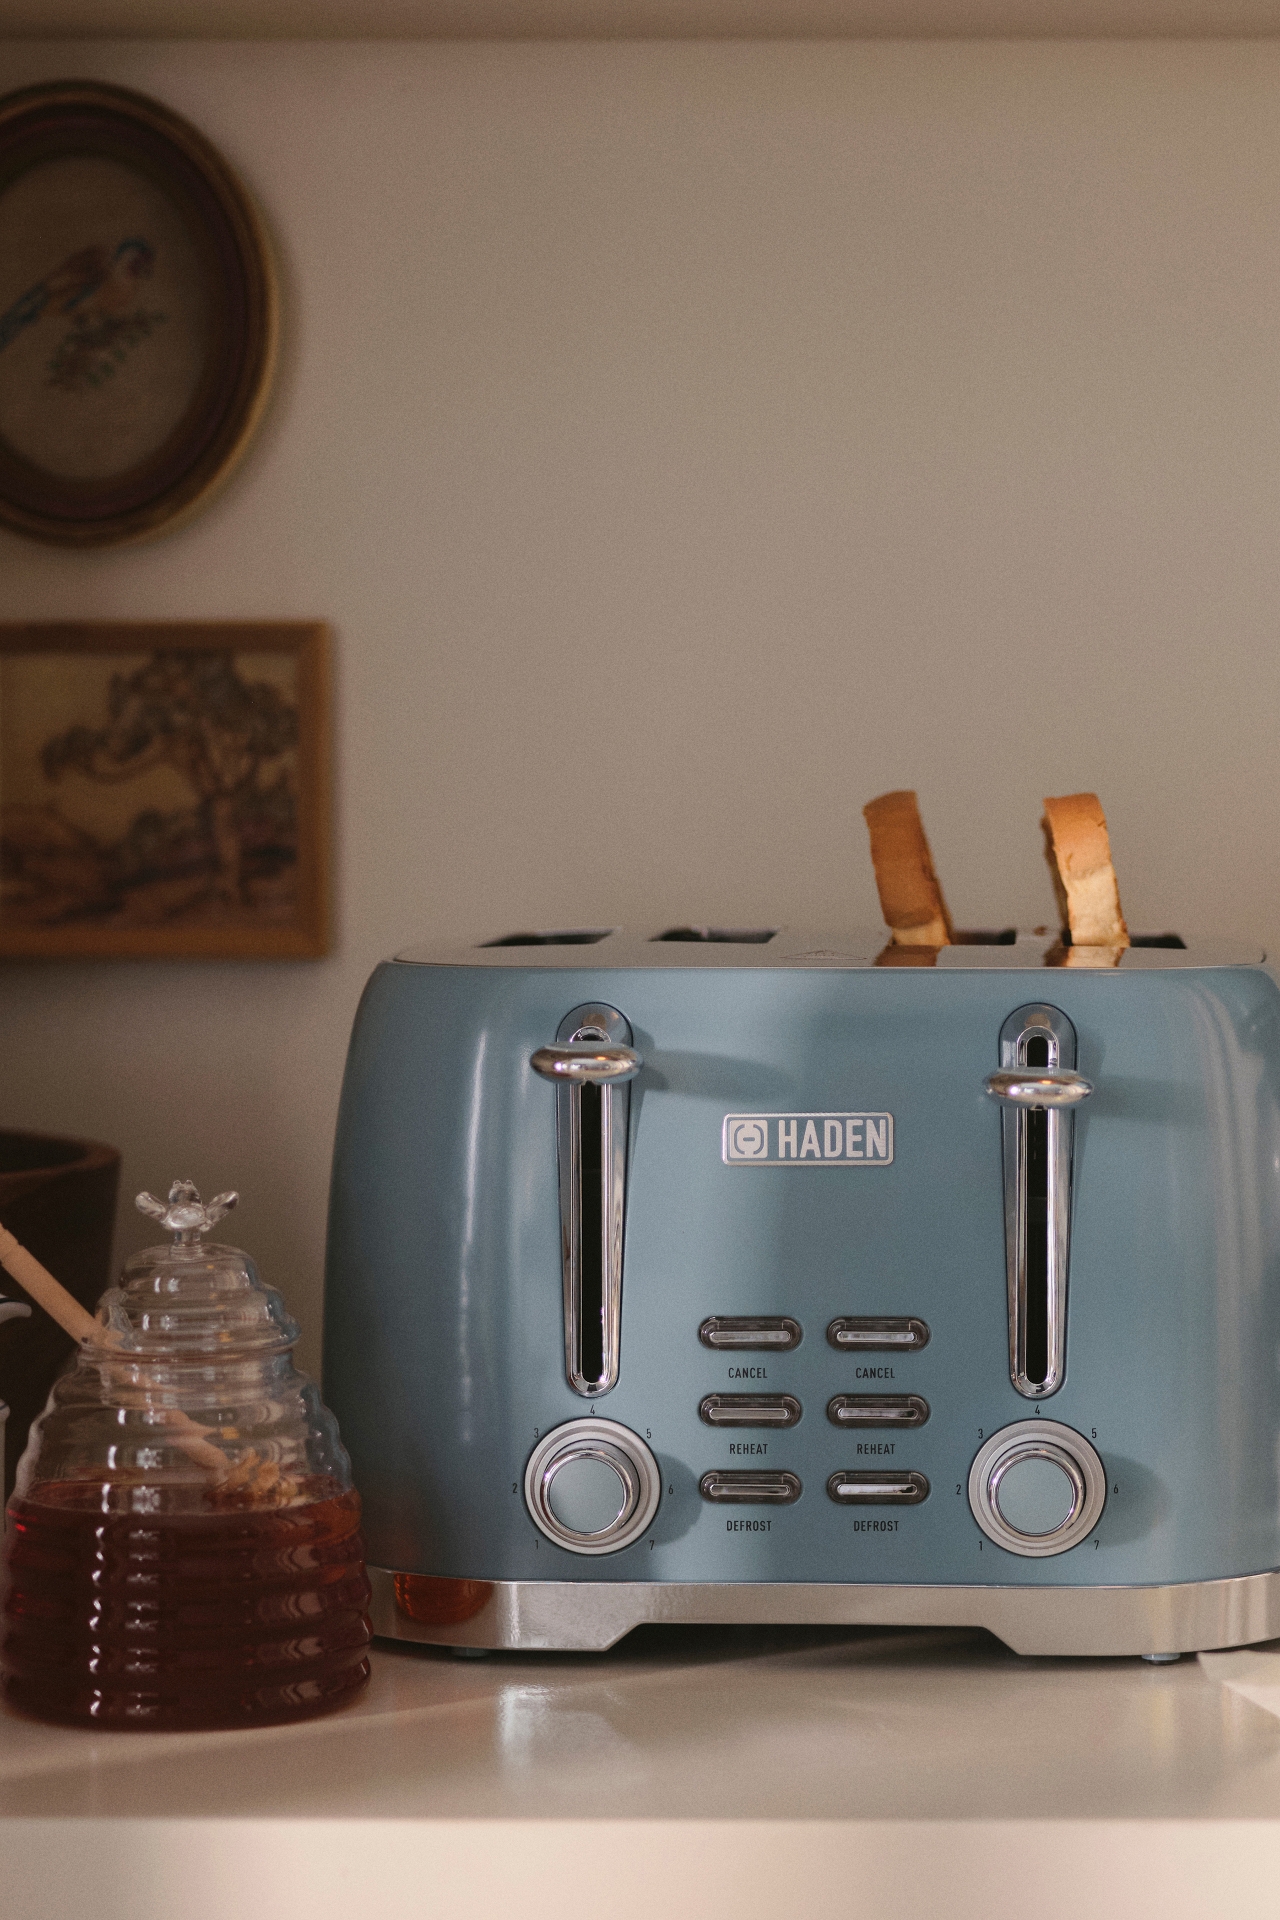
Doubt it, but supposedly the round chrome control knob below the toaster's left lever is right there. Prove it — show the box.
[524,1419,662,1553]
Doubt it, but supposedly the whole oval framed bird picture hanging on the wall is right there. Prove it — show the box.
[0,81,278,547]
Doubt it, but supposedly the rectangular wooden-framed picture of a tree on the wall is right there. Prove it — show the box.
[0,620,330,960]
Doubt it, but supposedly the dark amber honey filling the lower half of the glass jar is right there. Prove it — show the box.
[0,1480,370,1728]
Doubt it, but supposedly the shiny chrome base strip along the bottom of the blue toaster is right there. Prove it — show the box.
[368,1567,1280,1659]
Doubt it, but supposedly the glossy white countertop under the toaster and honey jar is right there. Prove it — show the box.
[0,1628,1280,1920]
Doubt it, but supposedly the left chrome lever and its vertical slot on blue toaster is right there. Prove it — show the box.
[530,1004,643,1400]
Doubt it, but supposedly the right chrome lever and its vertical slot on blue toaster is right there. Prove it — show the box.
[983,1006,1094,1400]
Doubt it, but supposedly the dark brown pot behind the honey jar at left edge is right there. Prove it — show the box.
[0,1131,121,1501]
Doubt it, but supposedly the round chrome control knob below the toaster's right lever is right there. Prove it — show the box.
[969,1419,1107,1559]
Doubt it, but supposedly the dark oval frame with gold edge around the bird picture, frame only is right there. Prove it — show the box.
[0,81,280,547]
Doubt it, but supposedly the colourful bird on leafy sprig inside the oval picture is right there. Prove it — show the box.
[0,238,165,394]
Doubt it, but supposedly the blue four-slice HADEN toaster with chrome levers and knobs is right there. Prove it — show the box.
[324,927,1280,1659]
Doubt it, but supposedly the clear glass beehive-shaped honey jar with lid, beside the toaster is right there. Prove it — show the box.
[0,1181,370,1728]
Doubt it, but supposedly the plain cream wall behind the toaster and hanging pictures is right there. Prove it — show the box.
[0,42,1280,1363]
